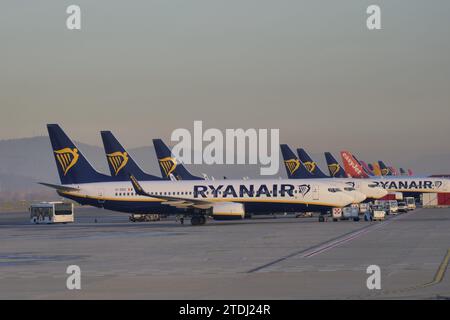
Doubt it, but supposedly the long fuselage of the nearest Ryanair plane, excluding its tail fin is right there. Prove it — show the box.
[59,179,354,213]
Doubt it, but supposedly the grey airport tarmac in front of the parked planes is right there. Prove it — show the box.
[0,208,450,299]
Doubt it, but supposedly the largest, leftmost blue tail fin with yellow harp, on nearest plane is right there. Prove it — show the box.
[47,124,112,184]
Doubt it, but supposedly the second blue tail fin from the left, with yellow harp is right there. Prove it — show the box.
[100,131,161,181]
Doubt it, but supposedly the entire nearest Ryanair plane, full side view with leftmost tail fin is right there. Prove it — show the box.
[41,124,354,225]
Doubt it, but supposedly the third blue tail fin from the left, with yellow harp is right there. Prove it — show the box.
[153,139,205,180]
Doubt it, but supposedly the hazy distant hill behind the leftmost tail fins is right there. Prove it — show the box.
[0,136,259,200]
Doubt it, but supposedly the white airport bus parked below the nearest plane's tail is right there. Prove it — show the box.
[30,201,74,224]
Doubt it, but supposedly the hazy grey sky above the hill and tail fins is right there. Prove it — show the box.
[0,0,450,161]
